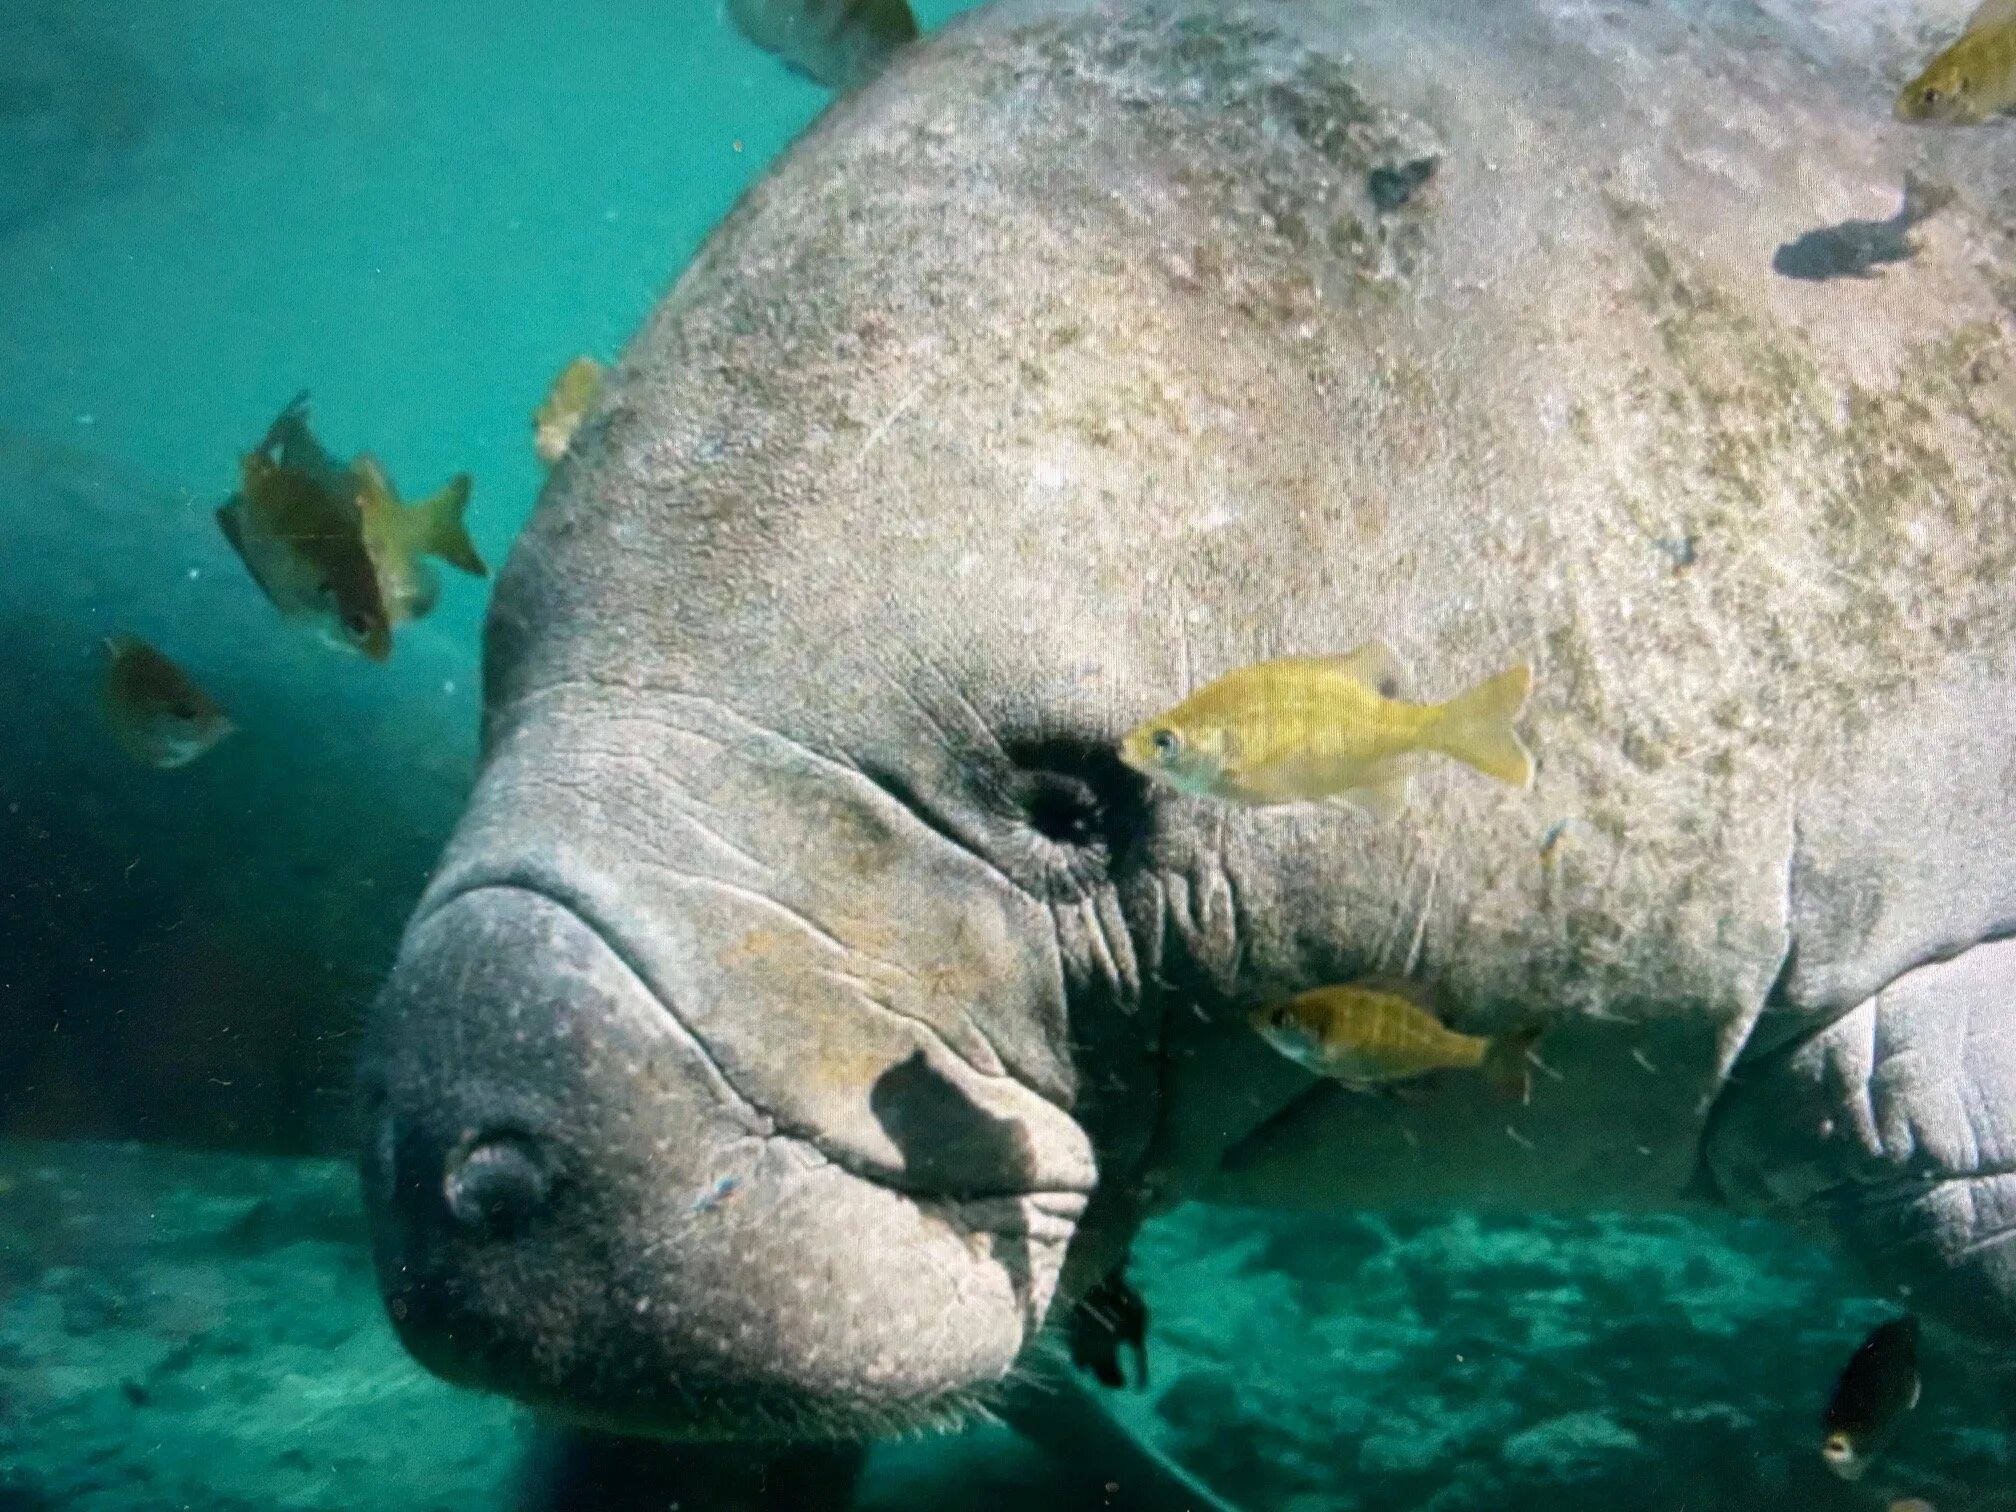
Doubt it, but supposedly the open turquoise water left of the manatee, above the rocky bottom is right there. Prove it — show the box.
[0,0,975,1149]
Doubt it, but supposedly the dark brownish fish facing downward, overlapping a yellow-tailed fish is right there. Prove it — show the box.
[218,450,391,661]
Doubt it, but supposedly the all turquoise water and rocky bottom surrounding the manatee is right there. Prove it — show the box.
[0,0,2016,1512]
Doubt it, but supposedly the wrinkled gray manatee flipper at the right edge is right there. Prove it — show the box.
[1706,939,2016,1413]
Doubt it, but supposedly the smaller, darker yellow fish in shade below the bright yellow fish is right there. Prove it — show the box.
[1252,978,1540,1103]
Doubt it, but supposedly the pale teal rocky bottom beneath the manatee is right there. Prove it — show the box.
[0,1143,2016,1512]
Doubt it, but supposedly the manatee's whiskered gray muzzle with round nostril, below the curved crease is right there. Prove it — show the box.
[363,885,1083,1437]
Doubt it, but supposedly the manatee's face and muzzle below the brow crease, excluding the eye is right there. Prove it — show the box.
[365,657,1093,1437]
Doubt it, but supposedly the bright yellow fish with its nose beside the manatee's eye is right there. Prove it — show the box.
[1121,641,1532,818]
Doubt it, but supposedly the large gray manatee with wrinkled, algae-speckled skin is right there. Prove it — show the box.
[365,0,2016,1486]
